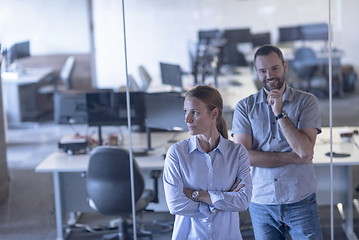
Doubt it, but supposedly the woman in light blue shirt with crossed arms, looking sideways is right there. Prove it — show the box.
[163,86,252,240]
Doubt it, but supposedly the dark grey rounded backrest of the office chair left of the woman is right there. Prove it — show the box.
[86,146,145,215]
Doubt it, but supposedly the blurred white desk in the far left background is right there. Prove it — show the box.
[1,68,53,126]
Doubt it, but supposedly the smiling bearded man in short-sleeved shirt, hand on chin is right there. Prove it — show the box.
[232,45,322,240]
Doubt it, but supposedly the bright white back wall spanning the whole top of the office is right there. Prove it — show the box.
[0,0,359,87]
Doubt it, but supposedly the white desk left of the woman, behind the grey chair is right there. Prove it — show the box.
[35,132,189,240]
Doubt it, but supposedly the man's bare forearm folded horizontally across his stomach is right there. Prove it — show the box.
[233,134,312,168]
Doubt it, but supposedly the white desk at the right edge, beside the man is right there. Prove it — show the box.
[314,127,359,239]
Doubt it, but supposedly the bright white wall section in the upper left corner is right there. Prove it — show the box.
[0,0,90,55]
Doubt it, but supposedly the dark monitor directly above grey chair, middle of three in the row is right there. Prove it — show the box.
[86,92,145,126]
